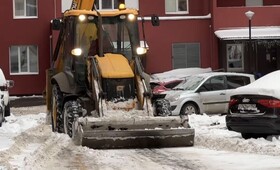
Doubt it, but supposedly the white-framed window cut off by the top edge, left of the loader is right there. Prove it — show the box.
[13,0,38,18]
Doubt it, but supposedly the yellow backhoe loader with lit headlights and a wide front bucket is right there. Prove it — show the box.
[46,0,194,149]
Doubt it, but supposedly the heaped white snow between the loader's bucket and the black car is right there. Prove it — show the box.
[189,114,280,156]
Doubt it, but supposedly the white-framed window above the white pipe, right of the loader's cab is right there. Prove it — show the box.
[165,0,189,14]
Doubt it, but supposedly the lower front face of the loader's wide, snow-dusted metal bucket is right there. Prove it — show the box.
[82,129,194,149]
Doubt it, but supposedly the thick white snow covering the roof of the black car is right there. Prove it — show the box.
[232,70,280,99]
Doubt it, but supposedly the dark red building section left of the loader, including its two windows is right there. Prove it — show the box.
[0,0,61,95]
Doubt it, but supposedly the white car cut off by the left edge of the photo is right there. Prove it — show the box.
[0,68,14,127]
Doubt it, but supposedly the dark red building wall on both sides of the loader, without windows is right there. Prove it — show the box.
[0,0,280,95]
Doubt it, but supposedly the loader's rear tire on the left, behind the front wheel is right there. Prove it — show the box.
[51,84,64,133]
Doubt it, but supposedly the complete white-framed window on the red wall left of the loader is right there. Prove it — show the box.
[10,45,38,74]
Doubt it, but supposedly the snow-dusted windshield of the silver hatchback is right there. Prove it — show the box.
[173,76,205,90]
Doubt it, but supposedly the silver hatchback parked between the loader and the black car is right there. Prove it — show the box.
[165,72,255,115]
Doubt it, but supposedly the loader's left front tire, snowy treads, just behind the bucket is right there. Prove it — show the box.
[63,100,82,138]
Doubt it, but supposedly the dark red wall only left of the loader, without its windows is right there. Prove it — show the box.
[0,0,59,95]
